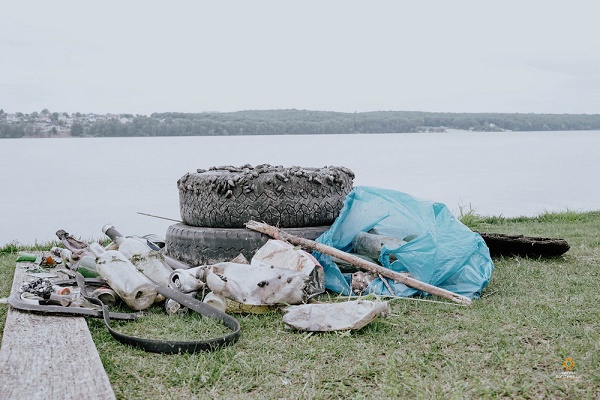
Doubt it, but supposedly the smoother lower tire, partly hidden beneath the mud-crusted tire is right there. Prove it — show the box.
[165,224,329,266]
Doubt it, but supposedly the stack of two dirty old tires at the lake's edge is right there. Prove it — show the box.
[165,164,354,265]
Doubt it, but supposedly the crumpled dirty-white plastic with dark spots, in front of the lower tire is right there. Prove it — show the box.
[205,262,309,305]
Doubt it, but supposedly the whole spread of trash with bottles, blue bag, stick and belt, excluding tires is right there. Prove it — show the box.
[9,187,493,352]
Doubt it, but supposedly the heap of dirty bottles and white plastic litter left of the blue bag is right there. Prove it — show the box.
[9,225,389,351]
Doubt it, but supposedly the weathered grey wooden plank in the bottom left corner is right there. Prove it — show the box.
[0,263,115,400]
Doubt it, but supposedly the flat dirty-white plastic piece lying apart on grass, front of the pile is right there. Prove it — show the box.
[283,300,390,332]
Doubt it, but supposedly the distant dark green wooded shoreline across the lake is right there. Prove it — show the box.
[0,110,600,137]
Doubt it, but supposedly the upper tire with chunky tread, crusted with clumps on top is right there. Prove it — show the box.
[177,164,354,228]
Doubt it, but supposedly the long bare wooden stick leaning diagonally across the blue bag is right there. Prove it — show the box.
[246,221,472,305]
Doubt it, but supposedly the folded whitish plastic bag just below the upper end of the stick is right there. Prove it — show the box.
[250,239,325,297]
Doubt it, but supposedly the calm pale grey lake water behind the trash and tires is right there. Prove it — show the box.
[0,131,600,245]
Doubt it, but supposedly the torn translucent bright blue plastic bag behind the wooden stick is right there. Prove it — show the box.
[314,186,494,298]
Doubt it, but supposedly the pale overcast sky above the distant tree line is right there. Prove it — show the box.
[0,0,600,115]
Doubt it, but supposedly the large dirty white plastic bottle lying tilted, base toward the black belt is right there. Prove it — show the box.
[88,243,156,310]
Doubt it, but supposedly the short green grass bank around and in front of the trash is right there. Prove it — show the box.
[0,212,600,399]
